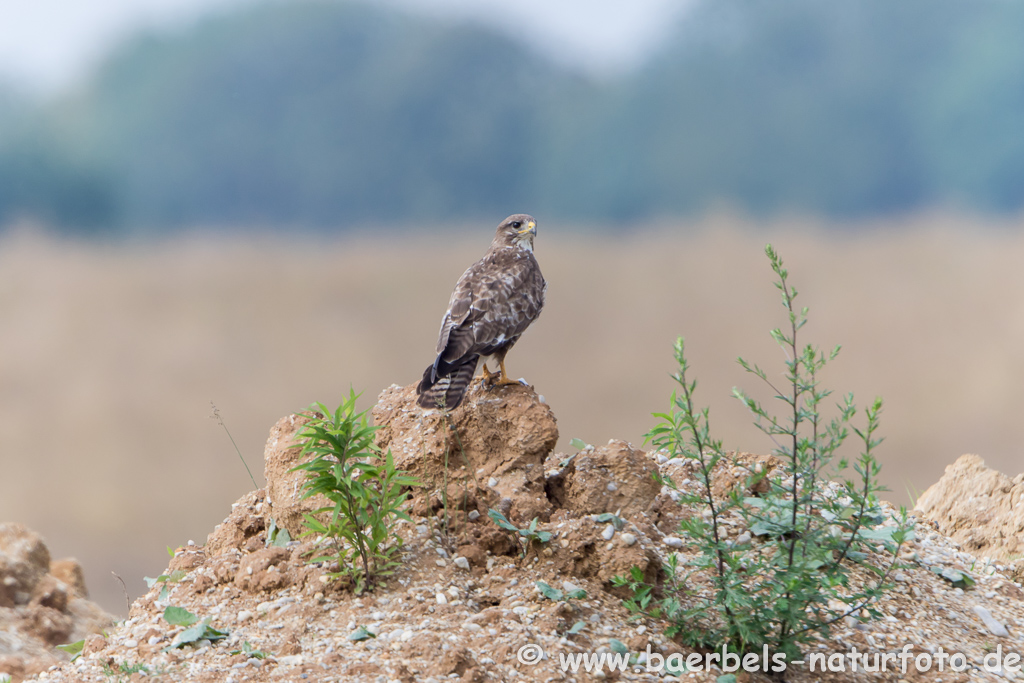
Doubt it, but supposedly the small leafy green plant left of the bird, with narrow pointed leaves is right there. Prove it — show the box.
[293,391,418,593]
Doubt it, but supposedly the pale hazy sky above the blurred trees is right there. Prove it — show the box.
[0,0,691,91]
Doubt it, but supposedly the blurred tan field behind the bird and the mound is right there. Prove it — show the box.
[0,217,1024,614]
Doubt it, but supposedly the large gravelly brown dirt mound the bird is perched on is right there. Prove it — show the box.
[28,386,1024,683]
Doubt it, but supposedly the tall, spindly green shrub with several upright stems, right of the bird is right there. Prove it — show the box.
[615,245,910,659]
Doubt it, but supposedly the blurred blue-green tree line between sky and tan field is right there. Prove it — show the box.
[0,0,1024,233]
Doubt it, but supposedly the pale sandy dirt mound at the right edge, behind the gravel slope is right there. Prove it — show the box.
[914,455,1024,560]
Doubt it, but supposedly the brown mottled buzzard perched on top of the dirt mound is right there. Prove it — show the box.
[416,213,548,410]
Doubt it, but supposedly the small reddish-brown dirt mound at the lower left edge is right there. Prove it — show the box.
[0,523,114,681]
